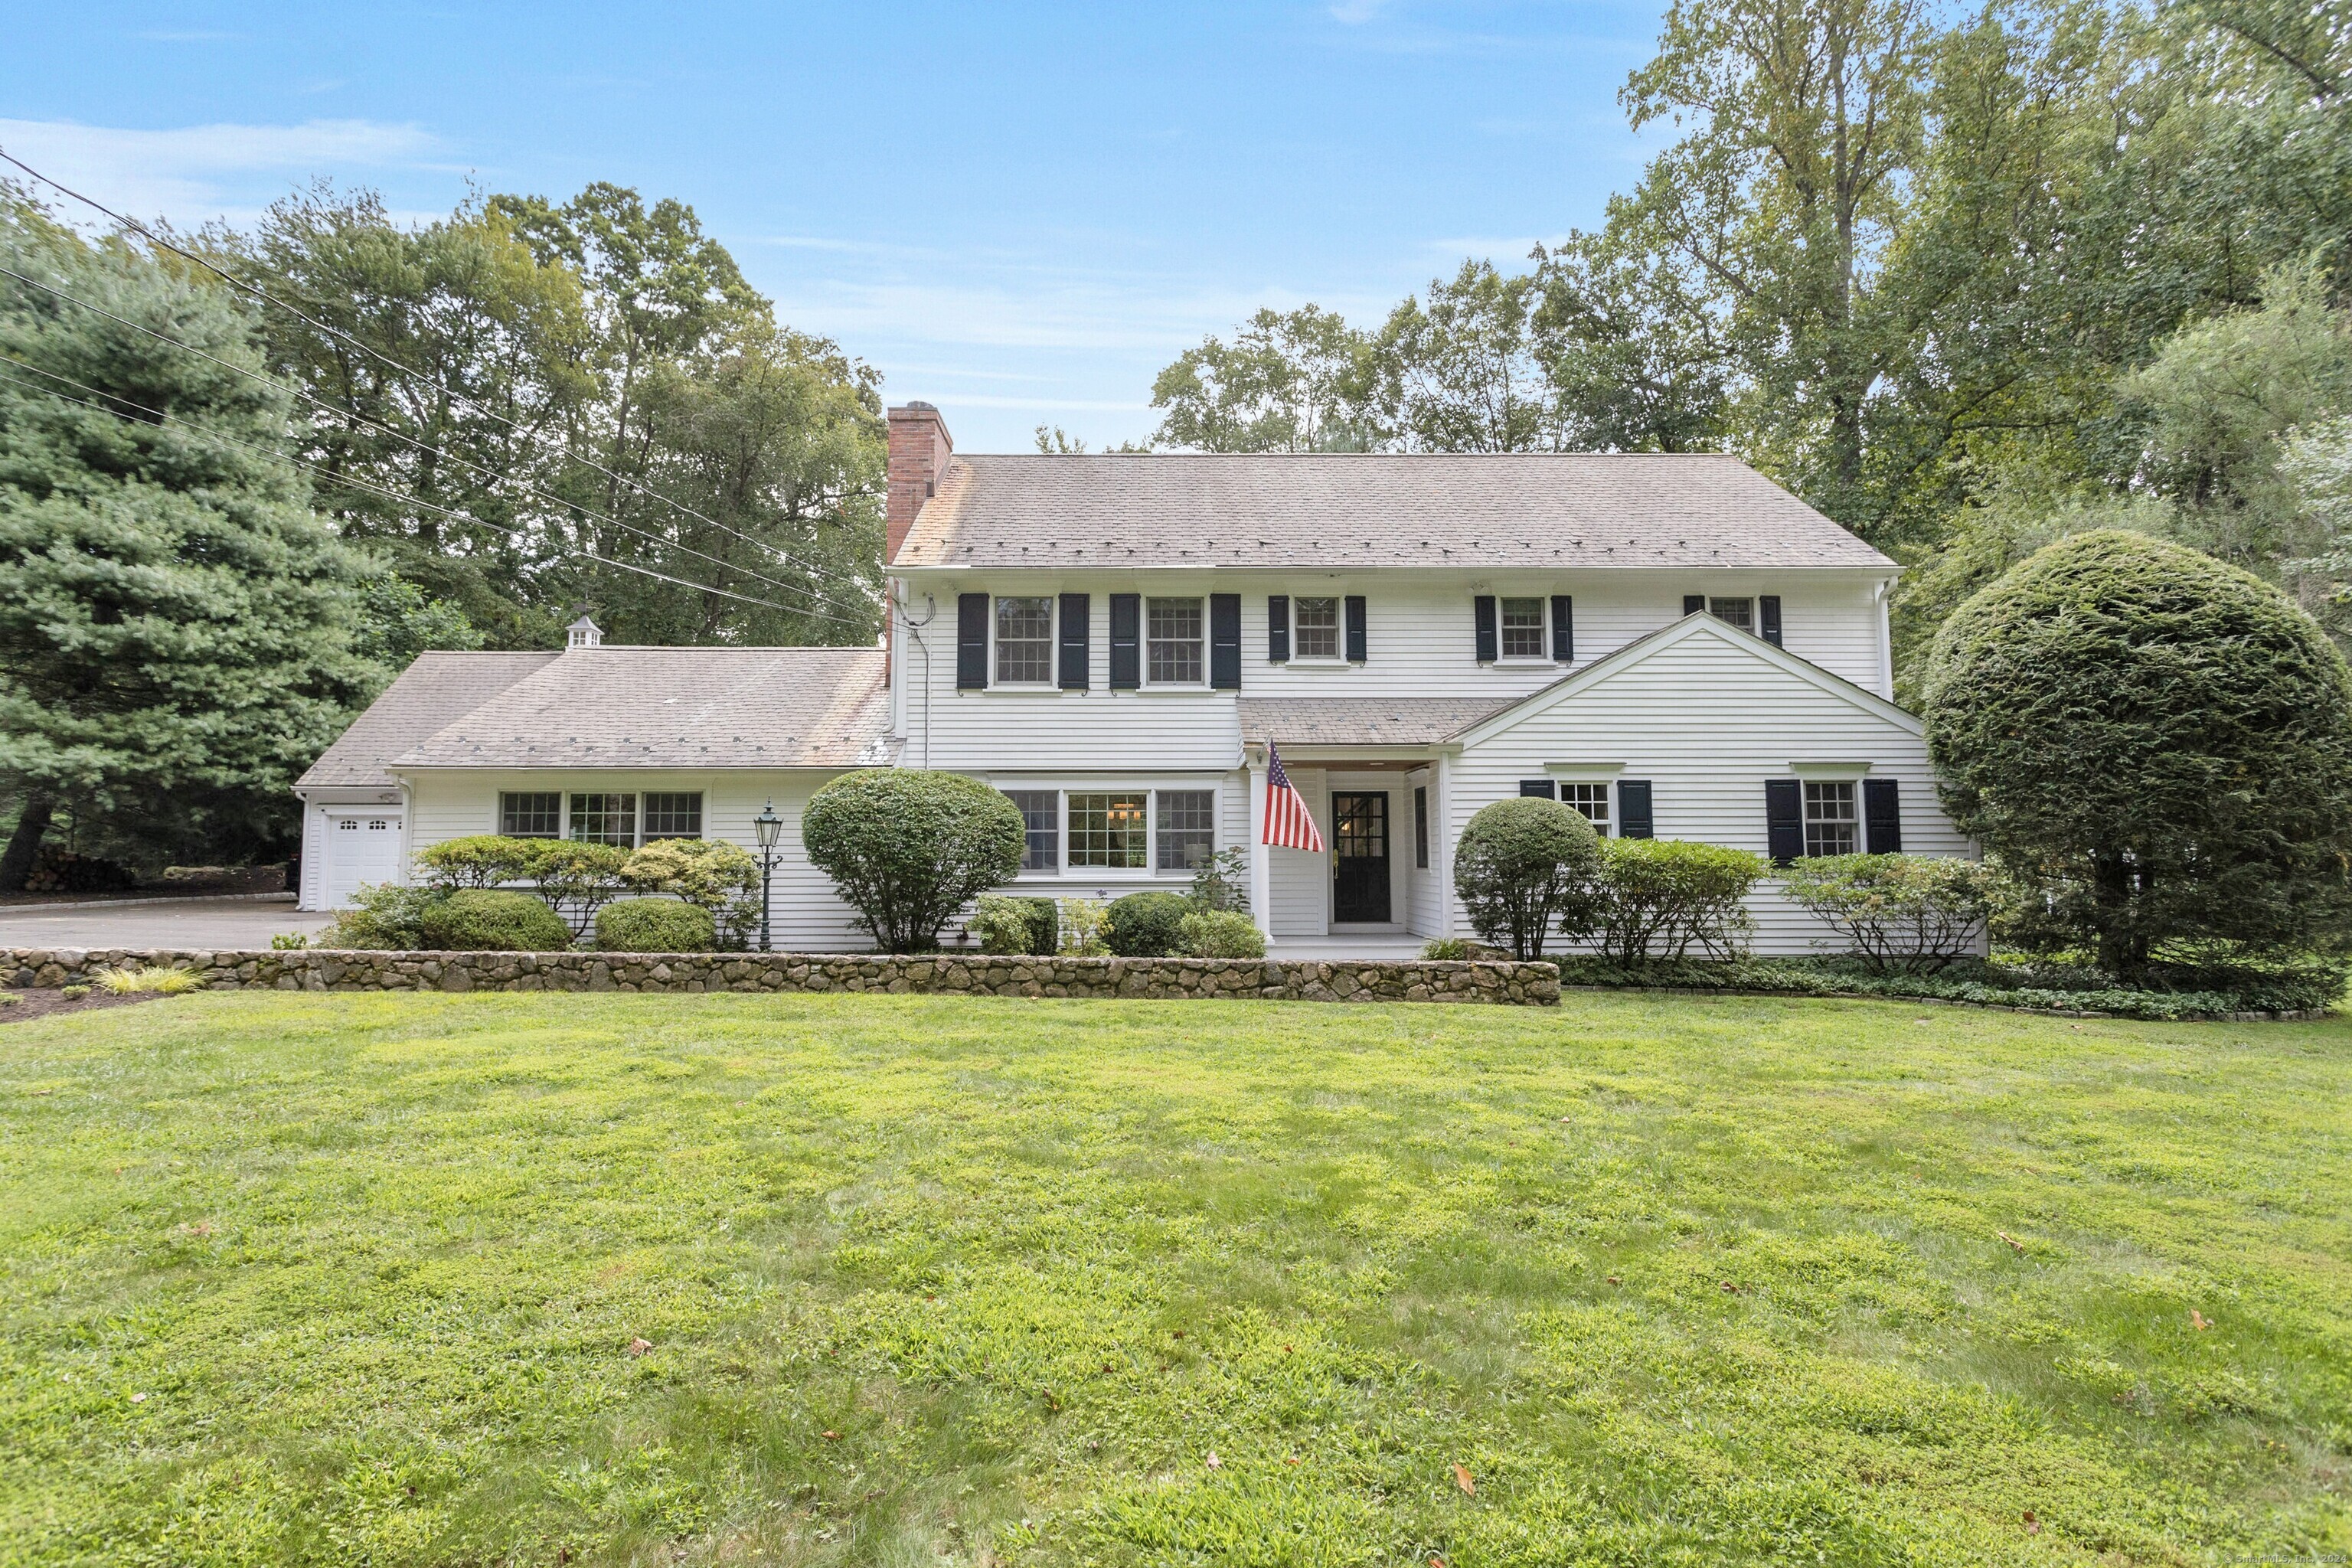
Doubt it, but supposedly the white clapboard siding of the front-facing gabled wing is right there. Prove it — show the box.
[1446,628,1973,955]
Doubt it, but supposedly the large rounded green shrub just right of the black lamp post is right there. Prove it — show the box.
[799,769,1027,952]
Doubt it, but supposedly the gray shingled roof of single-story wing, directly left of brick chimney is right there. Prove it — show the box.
[393,646,891,769]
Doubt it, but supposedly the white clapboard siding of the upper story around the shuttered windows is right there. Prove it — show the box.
[893,569,1886,771]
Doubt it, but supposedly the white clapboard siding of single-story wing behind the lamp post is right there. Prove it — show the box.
[410,769,873,952]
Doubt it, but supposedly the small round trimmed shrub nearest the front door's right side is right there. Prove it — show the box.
[1453,797,1602,959]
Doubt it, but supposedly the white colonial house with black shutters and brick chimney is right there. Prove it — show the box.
[299,402,1968,955]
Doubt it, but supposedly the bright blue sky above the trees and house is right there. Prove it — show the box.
[0,0,1658,452]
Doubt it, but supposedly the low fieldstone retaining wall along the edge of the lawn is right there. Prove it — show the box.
[18,947,1560,1006]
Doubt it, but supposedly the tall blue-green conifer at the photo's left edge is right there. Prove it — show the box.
[0,193,384,874]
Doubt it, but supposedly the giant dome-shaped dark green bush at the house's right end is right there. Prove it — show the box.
[1926,541,2352,978]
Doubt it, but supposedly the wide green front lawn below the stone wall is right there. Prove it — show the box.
[0,995,2352,1568]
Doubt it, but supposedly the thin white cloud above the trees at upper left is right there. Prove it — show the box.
[0,120,439,224]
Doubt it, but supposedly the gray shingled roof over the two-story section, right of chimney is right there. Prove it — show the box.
[891,452,1893,569]
